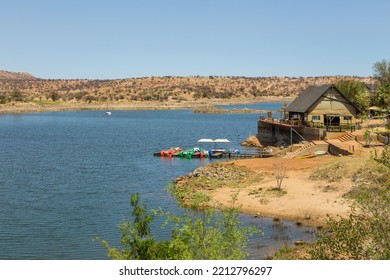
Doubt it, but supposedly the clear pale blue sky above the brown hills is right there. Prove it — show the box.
[0,0,390,79]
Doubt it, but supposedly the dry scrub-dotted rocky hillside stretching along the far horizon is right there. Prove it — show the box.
[0,71,374,104]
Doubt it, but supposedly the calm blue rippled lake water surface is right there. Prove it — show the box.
[0,103,313,259]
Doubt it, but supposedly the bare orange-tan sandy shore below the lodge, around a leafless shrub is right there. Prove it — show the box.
[178,155,368,226]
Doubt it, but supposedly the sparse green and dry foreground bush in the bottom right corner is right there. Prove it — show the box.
[309,148,390,260]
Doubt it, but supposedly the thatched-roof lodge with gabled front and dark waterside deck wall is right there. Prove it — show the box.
[258,84,361,145]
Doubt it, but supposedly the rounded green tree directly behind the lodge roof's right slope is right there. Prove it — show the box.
[336,80,370,111]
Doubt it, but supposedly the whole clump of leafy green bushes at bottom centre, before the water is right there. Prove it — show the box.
[102,194,259,260]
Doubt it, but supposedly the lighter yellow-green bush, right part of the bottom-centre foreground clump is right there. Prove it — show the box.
[159,192,261,260]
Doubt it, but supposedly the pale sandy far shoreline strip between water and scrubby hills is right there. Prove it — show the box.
[0,96,292,114]
